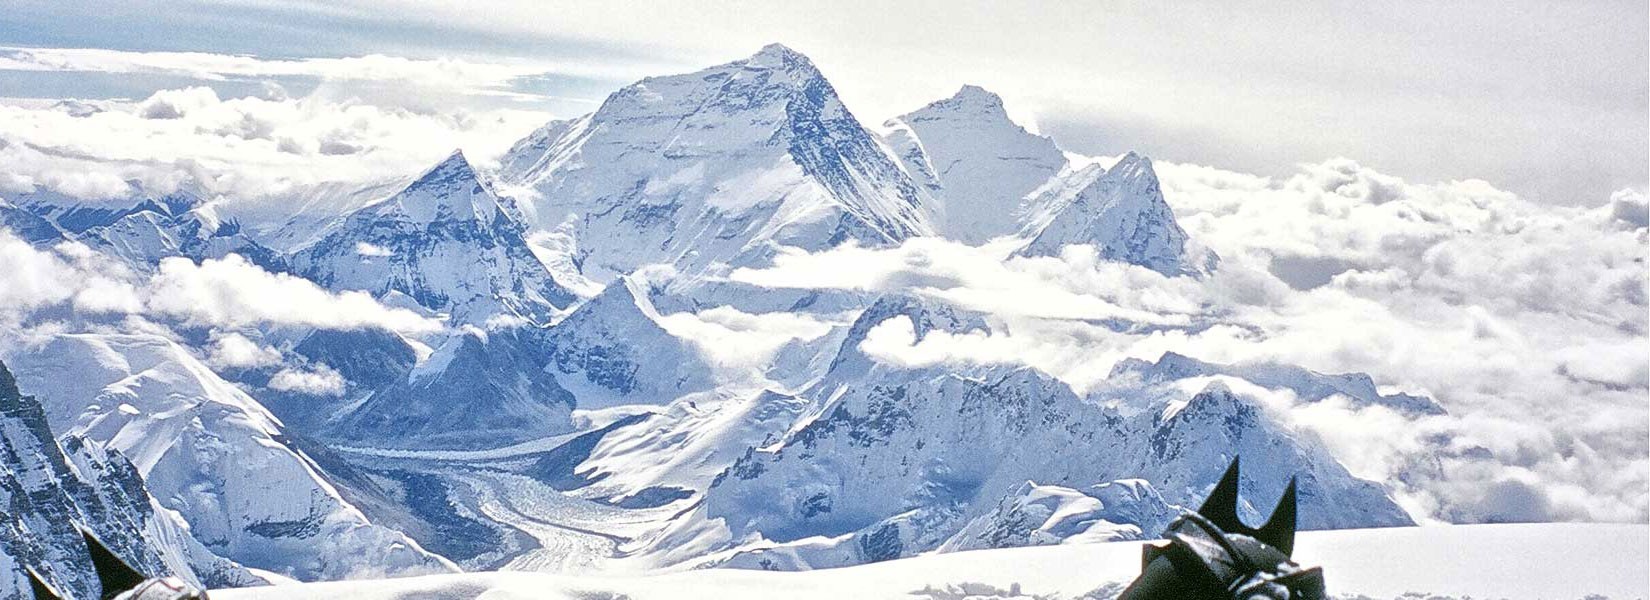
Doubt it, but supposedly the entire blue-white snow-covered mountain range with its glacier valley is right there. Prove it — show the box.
[0,45,1498,597]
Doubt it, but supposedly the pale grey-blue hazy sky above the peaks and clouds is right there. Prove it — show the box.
[0,0,1650,204]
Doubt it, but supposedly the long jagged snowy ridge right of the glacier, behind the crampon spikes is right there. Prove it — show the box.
[655,298,1411,569]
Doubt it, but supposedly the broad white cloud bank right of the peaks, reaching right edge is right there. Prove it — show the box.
[731,160,1650,521]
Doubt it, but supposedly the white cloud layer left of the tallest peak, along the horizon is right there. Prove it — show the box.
[0,87,545,210]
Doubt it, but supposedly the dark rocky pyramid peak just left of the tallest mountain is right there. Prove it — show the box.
[292,152,574,323]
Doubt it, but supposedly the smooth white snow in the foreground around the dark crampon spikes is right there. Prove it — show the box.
[213,524,1650,600]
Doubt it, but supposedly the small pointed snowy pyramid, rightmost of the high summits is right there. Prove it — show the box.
[1021,152,1218,277]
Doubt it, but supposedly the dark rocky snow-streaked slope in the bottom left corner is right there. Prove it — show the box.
[0,363,262,598]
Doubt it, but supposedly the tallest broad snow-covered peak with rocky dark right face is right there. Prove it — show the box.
[502,45,932,284]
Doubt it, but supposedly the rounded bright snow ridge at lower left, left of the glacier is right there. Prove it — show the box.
[4,335,450,579]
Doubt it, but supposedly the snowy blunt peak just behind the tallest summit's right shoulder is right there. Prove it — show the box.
[883,86,1068,244]
